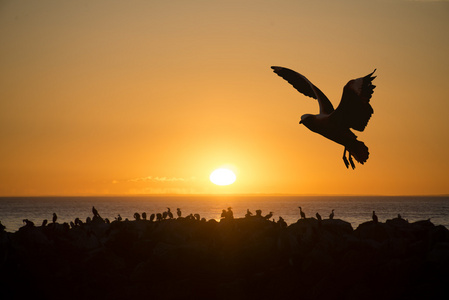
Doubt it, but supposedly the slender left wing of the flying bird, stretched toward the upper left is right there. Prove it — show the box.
[271,67,334,114]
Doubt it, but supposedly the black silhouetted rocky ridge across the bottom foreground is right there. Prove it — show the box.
[0,210,449,299]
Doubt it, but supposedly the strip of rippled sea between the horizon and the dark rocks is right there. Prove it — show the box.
[0,195,449,232]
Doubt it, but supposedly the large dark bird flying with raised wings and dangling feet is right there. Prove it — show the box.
[271,67,376,169]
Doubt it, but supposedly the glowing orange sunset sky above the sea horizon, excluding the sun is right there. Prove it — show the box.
[0,0,449,196]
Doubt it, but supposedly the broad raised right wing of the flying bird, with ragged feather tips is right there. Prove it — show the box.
[330,70,376,131]
